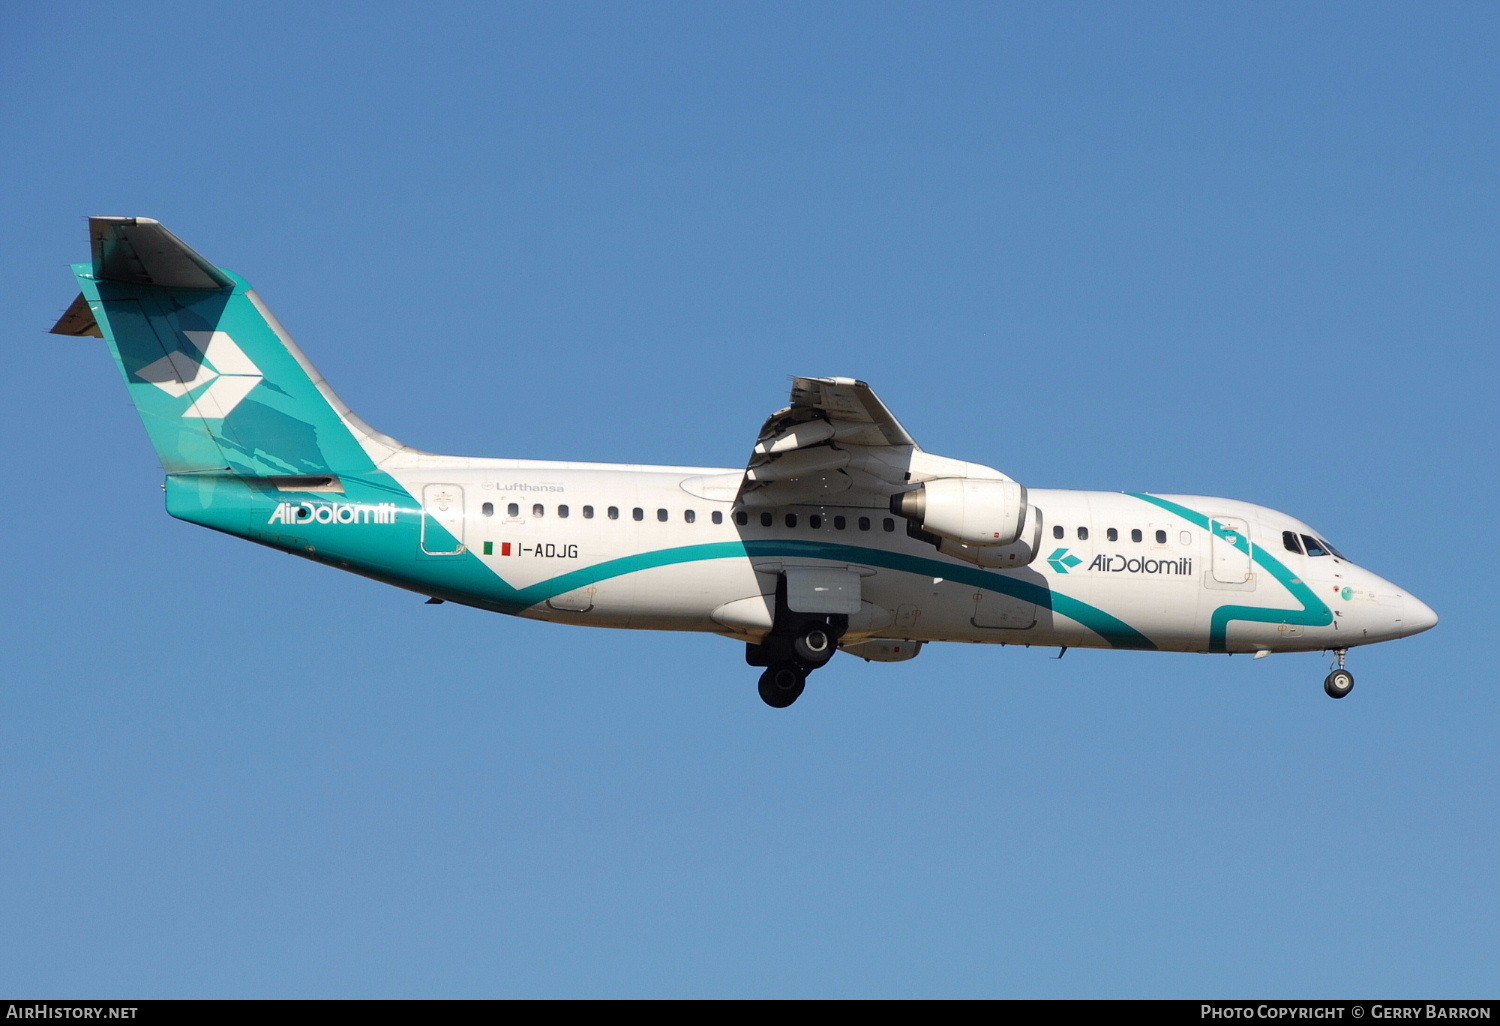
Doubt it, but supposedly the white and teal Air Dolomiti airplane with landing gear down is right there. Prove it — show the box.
[53,218,1437,708]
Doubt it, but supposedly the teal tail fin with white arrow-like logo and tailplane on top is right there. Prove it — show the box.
[53,218,404,477]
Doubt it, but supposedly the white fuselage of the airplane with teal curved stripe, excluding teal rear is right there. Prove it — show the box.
[375,458,1431,651]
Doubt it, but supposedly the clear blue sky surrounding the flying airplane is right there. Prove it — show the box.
[0,2,1500,998]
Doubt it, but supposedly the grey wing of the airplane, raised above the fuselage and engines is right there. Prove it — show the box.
[738,378,921,509]
